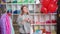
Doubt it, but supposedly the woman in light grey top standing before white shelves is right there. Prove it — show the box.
[17,5,32,34]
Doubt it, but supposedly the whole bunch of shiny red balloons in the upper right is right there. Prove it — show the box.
[40,0,58,13]
